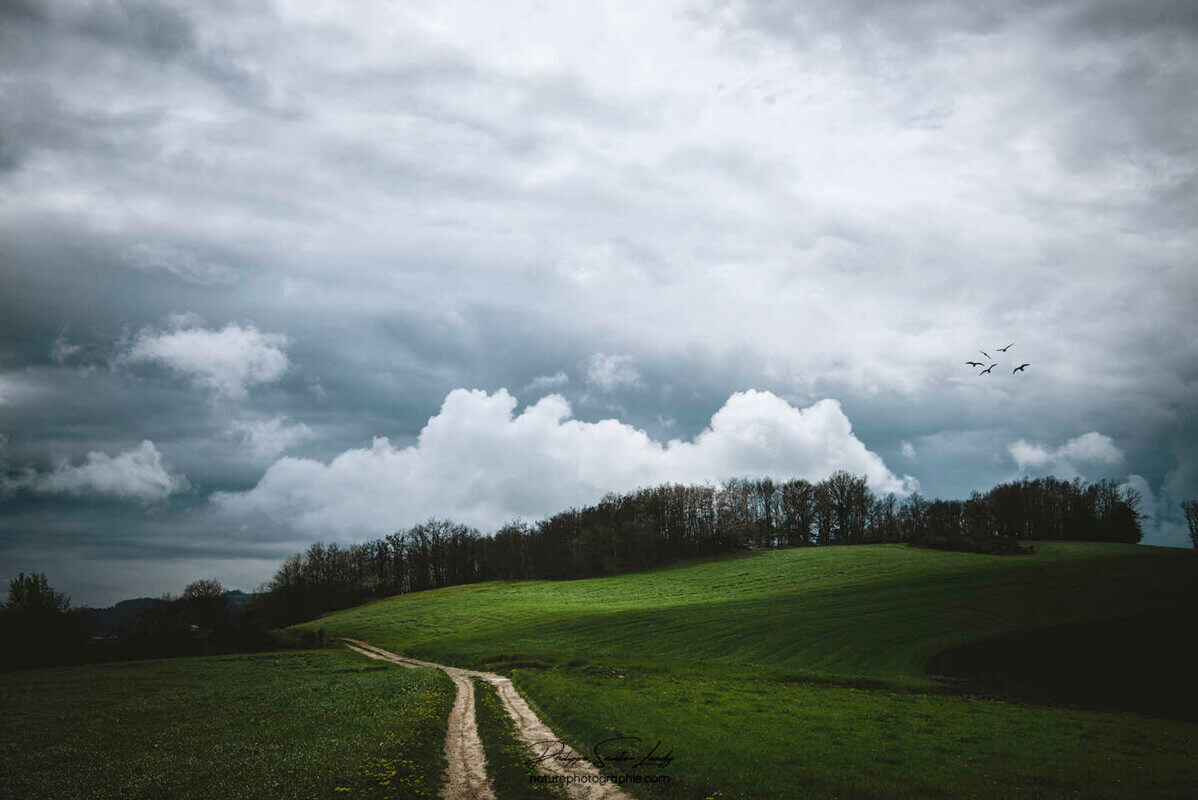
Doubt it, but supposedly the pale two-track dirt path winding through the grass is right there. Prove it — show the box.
[341,638,631,800]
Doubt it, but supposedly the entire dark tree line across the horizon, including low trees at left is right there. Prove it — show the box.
[9,472,1198,669]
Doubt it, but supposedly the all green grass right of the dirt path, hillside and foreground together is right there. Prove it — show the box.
[301,543,1198,798]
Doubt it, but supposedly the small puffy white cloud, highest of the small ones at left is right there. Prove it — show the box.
[123,316,288,398]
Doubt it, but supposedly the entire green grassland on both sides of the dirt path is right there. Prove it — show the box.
[7,543,1198,800]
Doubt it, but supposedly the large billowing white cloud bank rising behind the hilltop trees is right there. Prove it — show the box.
[212,389,916,537]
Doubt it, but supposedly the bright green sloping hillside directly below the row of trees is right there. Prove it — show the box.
[299,543,1198,685]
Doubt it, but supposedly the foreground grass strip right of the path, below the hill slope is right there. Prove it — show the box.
[518,669,1198,800]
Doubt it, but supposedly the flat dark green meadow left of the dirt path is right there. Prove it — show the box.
[0,650,454,800]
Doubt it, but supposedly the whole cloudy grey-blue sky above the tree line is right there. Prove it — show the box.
[0,0,1198,605]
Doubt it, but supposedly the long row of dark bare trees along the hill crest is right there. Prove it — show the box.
[259,471,1143,625]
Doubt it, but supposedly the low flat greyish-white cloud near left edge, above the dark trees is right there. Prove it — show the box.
[25,440,187,503]
